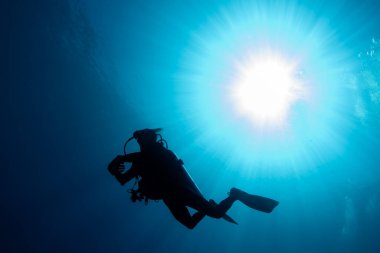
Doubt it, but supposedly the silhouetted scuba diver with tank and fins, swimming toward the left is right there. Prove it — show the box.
[108,128,279,229]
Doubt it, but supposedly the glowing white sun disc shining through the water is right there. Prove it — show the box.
[230,52,304,127]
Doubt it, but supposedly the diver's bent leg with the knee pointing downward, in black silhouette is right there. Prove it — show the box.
[163,198,206,229]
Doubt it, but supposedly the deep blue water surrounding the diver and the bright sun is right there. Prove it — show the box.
[0,0,380,253]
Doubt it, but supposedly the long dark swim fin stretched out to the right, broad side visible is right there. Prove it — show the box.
[230,188,279,213]
